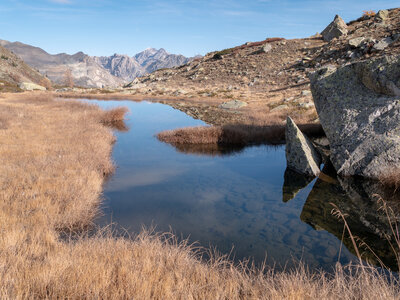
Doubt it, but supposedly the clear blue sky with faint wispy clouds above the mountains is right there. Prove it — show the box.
[0,0,400,56]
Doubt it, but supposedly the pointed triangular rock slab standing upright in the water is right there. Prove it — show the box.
[285,117,321,177]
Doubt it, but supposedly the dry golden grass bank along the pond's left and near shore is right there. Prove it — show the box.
[0,94,399,299]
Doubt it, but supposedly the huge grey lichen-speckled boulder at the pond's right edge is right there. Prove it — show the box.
[310,56,400,179]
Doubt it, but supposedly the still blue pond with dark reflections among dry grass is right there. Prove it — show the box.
[83,100,393,271]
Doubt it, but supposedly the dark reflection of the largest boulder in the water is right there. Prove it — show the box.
[300,166,398,270]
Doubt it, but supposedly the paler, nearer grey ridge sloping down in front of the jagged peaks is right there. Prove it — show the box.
[0,40,124,88]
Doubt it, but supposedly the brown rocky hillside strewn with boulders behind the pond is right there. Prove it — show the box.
[127,9,400,123]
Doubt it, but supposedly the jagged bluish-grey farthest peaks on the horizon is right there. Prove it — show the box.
[94,48,191,82]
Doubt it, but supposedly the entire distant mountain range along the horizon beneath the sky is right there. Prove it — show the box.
[0,40,195,88]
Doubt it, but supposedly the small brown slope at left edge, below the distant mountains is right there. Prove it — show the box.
[0,46,51,92]
